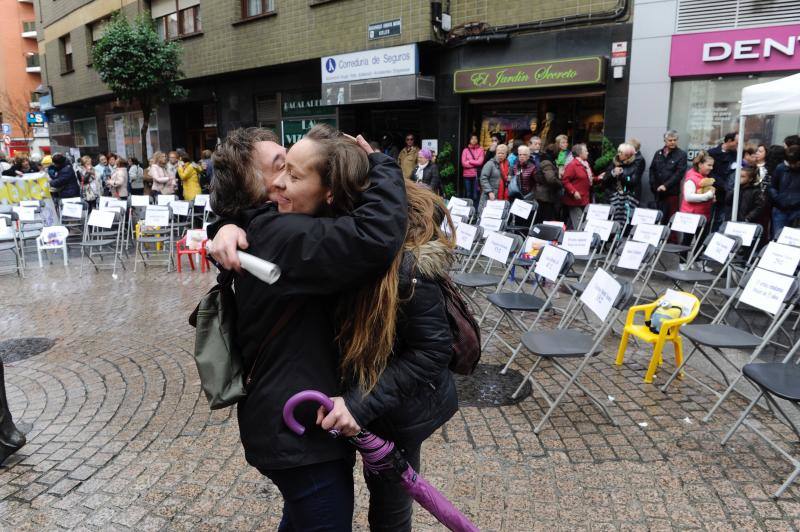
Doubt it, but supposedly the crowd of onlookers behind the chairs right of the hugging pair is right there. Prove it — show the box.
[460,130,800,241]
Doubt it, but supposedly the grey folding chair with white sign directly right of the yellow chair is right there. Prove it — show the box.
[661,268,798,396]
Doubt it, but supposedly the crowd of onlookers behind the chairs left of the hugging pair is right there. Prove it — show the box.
[0,149,214,210]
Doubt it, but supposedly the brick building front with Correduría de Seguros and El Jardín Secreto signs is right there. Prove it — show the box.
[39,0,631,181]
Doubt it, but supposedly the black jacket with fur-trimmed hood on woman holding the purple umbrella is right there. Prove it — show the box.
[344,242,458,447]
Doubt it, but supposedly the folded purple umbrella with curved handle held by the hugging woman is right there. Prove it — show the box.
[283,390,478,532]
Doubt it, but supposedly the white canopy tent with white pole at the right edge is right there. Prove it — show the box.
[732,74,800,221]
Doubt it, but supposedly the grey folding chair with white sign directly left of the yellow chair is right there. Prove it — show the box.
[512,268,632,434]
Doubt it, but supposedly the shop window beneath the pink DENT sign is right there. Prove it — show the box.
[669,77,800,159]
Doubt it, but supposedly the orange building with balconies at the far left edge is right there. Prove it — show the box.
[0,0,48,155]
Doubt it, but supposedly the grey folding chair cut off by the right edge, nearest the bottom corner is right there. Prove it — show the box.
[721,341,800,499]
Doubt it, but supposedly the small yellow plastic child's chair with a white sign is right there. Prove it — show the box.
[616,292,700,382]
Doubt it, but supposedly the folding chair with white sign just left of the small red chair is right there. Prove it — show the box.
[133,205,175,273]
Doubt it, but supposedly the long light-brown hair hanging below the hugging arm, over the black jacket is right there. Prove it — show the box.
[337,180,455,394]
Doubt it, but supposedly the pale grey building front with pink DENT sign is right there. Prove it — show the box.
[627,0,800,204]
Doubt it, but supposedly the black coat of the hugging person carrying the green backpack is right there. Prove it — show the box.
[210,153,407,469]
